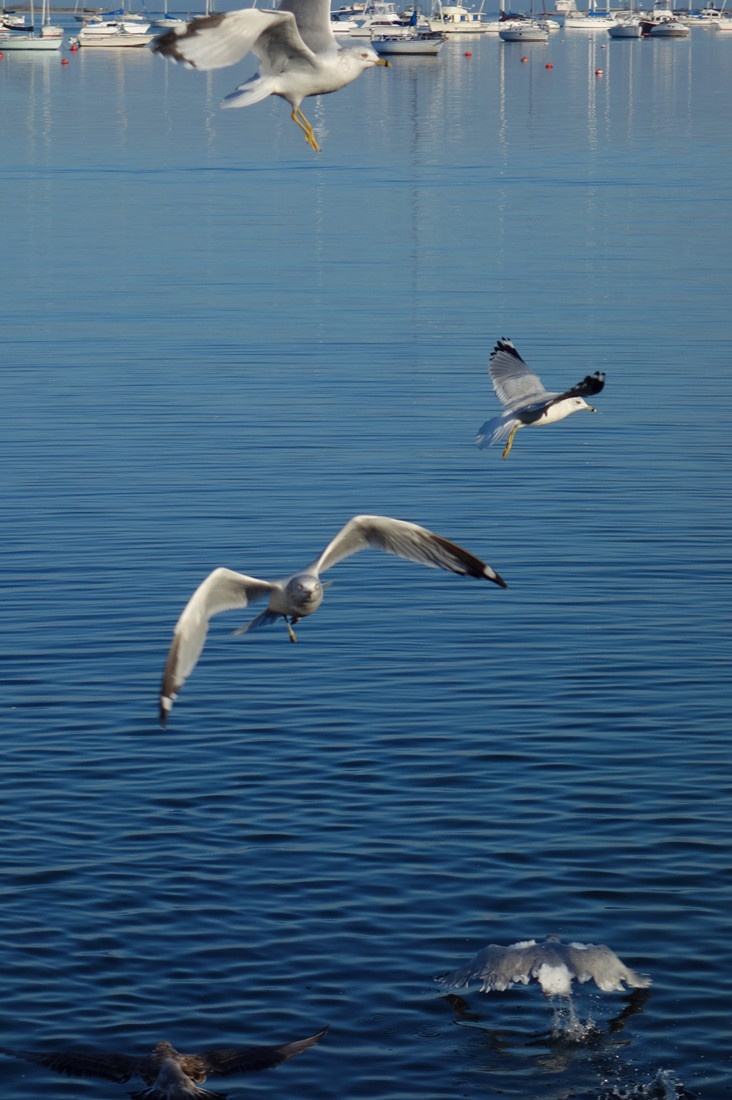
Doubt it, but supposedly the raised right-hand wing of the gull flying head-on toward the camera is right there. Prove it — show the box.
[308,516,507,589]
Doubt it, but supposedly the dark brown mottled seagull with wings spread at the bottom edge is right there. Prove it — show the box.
[0,1027,328,1100]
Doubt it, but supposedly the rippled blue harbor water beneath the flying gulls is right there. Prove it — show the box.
[0,21,732,1100]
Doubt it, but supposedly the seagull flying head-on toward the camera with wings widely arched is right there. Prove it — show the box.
[160,516,507,726]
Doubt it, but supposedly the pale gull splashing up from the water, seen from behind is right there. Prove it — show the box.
[435,936,651,997]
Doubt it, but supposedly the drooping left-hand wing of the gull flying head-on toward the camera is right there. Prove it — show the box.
[160,569,272,725]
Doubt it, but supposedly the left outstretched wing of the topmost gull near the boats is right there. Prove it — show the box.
[151,8,312,72]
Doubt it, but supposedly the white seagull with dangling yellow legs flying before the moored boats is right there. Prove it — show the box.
[151,0,389,153]
